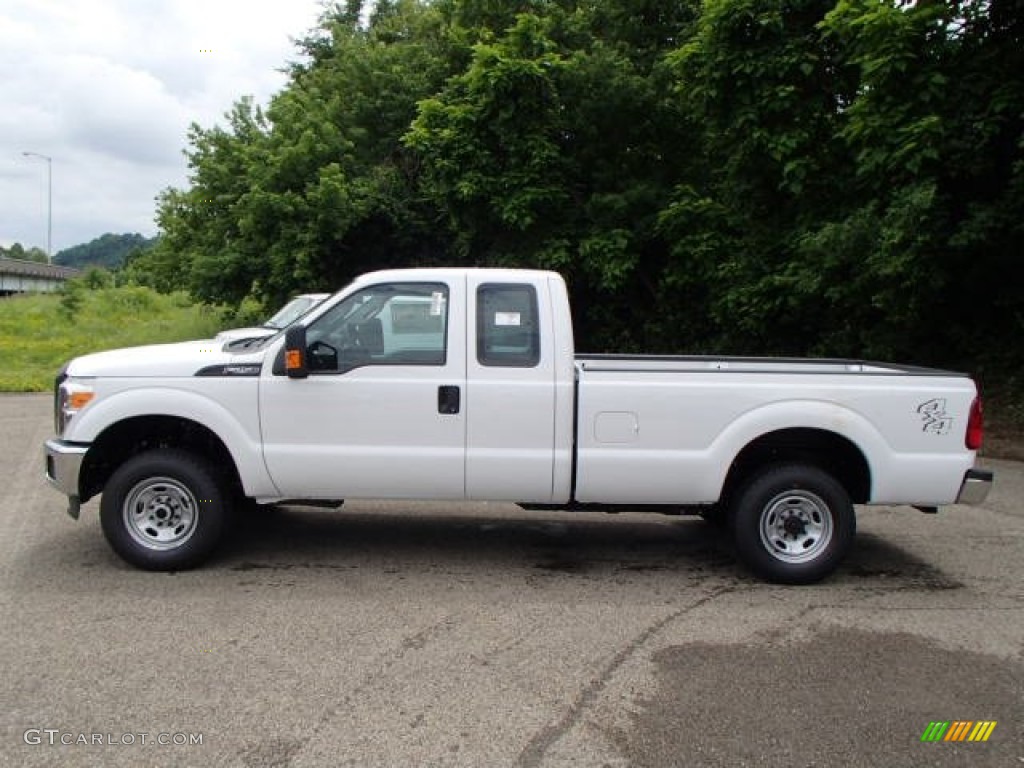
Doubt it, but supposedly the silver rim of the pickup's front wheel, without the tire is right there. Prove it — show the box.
[122,477,199,550]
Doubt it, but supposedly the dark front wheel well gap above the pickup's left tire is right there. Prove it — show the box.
[79,416,242,502]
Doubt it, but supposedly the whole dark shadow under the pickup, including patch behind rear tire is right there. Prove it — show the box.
[208,503,963,590]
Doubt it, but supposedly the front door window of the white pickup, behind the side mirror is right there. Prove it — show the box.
[306,283,449,374]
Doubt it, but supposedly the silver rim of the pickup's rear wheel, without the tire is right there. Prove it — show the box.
[761,490,833,563]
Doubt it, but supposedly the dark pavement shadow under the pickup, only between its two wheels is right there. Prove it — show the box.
[222,504,736,575]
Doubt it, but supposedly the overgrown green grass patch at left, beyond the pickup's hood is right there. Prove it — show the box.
[0,286,223,392]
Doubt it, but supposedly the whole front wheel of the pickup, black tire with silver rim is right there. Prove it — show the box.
[99,449,231,570]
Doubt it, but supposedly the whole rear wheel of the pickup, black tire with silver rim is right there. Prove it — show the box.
[732,464,857,584]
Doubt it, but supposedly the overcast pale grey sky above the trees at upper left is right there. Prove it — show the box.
[0,0,322,253]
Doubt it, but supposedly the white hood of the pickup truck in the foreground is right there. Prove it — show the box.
[67,339,264,377]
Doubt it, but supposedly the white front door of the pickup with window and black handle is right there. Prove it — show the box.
[259,275,466,499]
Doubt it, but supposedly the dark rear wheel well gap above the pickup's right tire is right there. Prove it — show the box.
[722,429,871,504]
